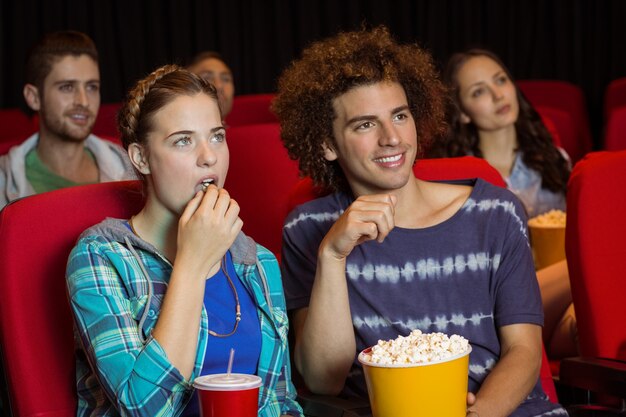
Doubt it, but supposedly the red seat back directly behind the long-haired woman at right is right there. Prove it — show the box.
[516,80,593,162]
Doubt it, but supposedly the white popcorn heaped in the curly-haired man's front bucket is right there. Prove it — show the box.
[364,330,469,365]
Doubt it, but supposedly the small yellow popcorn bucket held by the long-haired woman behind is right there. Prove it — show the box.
[528,222,565,270]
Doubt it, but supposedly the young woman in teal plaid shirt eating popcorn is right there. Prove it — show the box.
[67,65,302,417]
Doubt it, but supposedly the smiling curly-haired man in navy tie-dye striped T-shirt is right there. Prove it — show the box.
[274,27,567,417]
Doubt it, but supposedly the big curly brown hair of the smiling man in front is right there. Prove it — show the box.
[272,26,446,191]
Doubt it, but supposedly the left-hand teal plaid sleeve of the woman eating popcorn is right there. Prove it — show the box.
[67,239,191,416]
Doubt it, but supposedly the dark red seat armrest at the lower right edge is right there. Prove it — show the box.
[559,357,626,399]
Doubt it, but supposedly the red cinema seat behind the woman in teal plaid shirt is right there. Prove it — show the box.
[0,181,143,417]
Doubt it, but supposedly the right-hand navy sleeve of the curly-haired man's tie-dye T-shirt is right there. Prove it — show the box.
[494,198,543,327]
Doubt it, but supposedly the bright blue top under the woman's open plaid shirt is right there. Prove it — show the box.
[182,252,261,417]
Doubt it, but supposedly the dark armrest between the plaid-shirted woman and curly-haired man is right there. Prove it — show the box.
[298,392,372,417]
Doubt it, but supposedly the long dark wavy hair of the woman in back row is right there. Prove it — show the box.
[428,48,570,193]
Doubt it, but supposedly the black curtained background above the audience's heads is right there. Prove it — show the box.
[0,0,626,148]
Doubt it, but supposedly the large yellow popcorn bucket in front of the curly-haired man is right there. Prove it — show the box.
[359,347,472,417]
